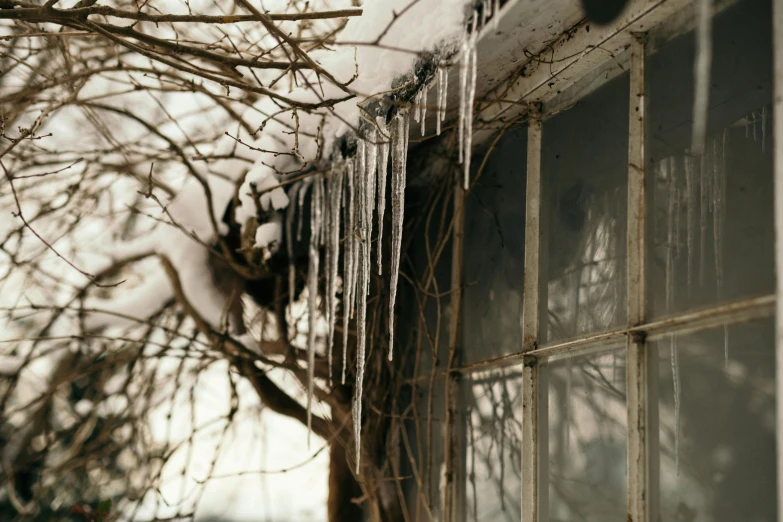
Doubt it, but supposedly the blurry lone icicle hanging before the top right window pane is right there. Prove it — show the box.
[691,0,712,154]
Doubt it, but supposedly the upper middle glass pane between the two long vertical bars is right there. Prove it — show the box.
[541,74,630,342]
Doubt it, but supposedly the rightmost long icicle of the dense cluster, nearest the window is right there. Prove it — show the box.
[389,110,408,361]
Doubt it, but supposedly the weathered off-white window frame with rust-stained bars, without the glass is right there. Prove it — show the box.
[443,0,783,522]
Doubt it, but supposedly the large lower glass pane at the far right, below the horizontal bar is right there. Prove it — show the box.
[652,319,777,522]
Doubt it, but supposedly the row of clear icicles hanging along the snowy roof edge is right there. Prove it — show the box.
[286,12,484,472]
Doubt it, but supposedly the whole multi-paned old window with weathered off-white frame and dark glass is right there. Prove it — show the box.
[414,0,783,522]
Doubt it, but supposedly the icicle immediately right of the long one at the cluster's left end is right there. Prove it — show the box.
[325,165,345,387]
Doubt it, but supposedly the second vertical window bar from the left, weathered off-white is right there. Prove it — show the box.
[522,114,546,522]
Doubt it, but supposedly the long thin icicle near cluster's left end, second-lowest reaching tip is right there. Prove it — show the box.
[307,176,323,448]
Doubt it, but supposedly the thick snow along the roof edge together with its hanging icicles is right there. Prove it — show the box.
[82,0,480,458]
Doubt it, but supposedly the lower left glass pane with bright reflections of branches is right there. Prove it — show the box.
[465,368,522,522]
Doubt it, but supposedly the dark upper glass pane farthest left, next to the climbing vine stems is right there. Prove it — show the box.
[462,127,527,362]
